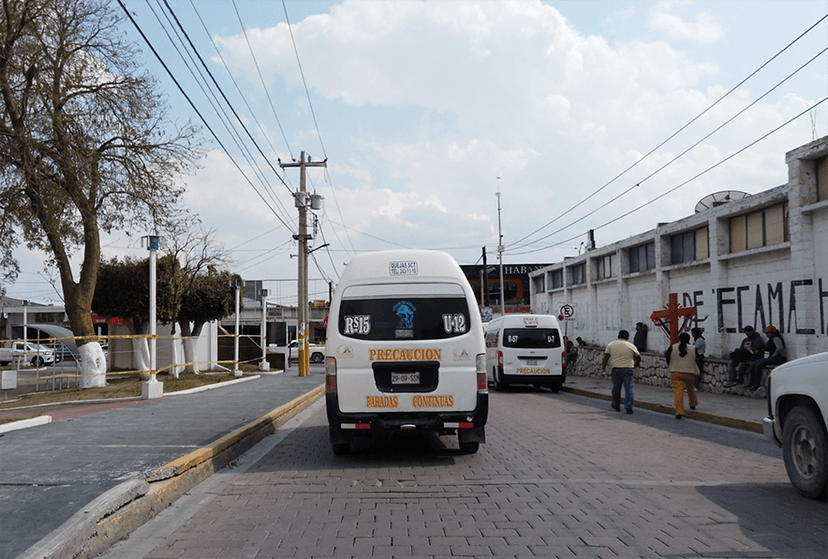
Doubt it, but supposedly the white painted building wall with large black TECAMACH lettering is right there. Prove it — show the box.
[530,137,828,358]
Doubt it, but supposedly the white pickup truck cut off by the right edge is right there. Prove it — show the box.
[762,352,828,500]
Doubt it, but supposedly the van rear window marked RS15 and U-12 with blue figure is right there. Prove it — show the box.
[338,294,471,341]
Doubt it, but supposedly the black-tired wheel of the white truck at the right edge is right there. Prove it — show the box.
[782,406,828,500]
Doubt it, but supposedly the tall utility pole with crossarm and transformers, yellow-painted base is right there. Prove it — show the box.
[279,151,327,377]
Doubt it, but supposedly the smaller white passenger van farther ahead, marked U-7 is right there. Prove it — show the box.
[485,314,565,392]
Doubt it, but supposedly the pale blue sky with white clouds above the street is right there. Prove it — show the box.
[6,0,828,305]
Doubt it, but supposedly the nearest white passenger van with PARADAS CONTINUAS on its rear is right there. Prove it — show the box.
[325,250,489,454]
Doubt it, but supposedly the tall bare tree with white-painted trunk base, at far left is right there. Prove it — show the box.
[0,0,202,387]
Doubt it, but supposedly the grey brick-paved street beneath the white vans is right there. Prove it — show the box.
[102,390,828,559]
